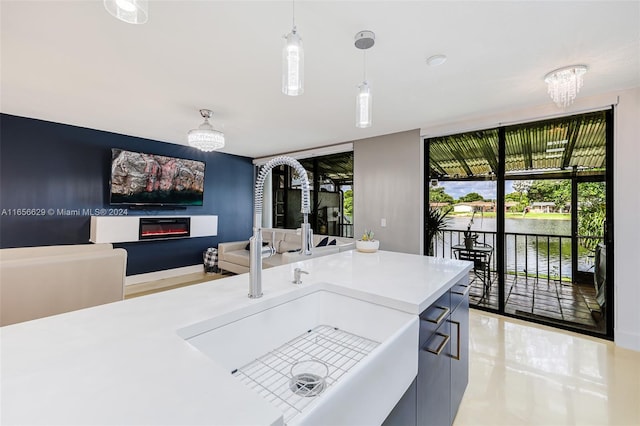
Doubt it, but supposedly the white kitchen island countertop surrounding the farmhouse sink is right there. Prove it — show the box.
[0,251,471,425]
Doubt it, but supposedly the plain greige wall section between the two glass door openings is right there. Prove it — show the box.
[353,129,424,254]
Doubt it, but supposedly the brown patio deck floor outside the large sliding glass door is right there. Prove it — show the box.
[469,271,606,334]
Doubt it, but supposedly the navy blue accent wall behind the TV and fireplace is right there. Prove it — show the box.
[0,114,253,275]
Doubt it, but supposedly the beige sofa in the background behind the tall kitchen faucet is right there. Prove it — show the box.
[218,228,355,274]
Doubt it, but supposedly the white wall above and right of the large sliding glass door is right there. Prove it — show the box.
[420,88,640,351]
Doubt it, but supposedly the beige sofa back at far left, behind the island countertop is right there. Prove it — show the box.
[0,244,127,326]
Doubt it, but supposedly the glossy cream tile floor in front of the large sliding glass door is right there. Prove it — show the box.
[454,309,640,426]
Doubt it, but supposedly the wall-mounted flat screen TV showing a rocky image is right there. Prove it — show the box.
[110,148,205,206]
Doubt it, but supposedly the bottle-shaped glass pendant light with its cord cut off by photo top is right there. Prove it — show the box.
[282,1,304,96]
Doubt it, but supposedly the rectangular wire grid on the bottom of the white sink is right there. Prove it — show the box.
[232,325,380,423]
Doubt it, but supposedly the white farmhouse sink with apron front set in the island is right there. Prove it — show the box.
[178,290,418,425]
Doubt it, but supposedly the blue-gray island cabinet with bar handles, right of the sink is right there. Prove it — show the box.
[383,281,469,426]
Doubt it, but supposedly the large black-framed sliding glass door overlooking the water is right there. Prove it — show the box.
[425,111,613,338]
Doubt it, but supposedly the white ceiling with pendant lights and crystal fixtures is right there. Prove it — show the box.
[0,0,640,157]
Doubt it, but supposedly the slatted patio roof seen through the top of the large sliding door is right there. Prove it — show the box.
[428,111,606,180]
